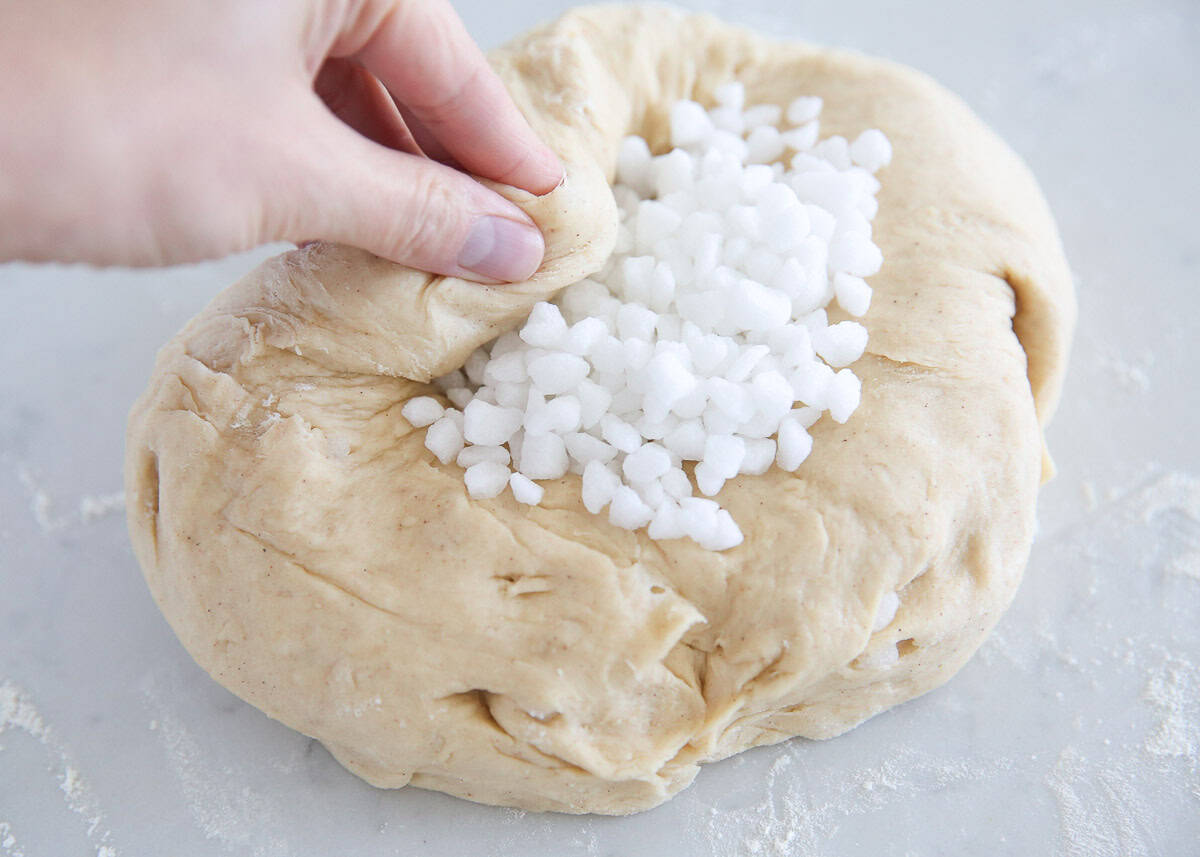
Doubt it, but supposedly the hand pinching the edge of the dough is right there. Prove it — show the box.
[0,0,563,282]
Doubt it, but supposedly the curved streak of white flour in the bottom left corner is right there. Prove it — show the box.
[0,679,116,857]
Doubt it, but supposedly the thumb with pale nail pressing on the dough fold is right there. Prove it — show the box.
[270,99,545,283]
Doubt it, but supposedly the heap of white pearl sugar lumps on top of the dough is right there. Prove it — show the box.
[417,88,892,550]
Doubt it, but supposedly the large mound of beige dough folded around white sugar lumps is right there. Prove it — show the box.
[126,7,1074,814]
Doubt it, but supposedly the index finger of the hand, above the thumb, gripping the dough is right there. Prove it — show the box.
[358,0,563,194]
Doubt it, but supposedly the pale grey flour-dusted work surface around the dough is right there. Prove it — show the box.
[0,0,1200,857]
